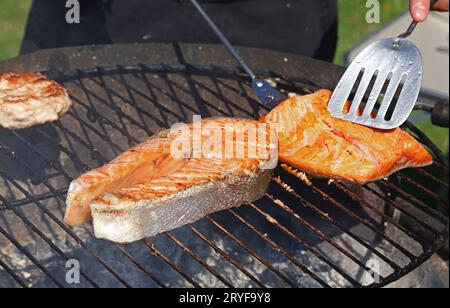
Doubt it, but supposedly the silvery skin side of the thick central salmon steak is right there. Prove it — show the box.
[91,166,272,243]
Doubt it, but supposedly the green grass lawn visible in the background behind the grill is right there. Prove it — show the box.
[0,0,449,154]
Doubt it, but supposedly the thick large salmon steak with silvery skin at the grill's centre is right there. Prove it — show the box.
[65,118,277,243]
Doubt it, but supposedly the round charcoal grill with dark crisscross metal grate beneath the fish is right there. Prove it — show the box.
[0,44,448,287]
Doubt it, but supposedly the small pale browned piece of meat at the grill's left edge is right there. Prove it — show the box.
[0,73,72,129]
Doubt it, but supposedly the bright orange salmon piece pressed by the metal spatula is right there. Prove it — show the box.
[260,90,433,184]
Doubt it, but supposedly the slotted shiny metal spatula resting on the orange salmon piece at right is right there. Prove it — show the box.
[328,1,437,129]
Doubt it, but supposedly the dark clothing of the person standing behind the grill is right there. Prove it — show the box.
[22,0,337,61]
